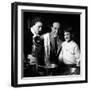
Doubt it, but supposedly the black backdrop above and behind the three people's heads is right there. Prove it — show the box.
[23,11,80,48]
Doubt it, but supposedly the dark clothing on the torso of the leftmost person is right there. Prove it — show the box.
[32,36,44,65]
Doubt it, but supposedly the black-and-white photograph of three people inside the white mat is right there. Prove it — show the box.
[22,11,80,77]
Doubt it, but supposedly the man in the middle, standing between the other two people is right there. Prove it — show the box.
[44,22,62,74]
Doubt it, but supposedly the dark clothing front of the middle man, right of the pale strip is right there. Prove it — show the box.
[50,33,62,64]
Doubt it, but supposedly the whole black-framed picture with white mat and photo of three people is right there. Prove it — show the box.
[11,2,88,87]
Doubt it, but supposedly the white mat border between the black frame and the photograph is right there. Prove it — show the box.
[17,5,86,84]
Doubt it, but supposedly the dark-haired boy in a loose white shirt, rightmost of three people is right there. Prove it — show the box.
[59,28,80,75]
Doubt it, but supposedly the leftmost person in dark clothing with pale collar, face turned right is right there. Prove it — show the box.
[28,18,44,64]
